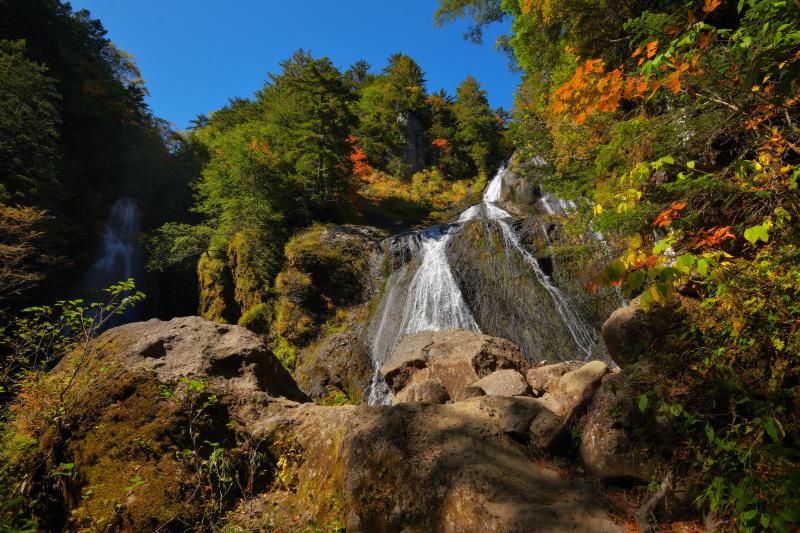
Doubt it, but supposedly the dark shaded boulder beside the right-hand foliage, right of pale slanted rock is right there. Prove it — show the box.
[580,364,659,482]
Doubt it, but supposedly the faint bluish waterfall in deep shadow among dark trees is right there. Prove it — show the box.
[83,197,143,325]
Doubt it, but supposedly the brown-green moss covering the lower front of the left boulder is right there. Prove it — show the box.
[0,341,238,531]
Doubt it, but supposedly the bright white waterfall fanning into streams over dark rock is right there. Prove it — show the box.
[368,163,608,405]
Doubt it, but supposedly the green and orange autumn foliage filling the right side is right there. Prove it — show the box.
[444,0,800,531]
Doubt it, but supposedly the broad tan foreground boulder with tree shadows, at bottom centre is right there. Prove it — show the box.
[241,396,624,533]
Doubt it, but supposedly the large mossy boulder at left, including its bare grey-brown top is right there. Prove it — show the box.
[0,317,305,531]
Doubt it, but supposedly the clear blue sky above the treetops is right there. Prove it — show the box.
[71,0,518,129]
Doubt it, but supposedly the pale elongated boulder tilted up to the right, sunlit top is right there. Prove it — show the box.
[531,361,610,449]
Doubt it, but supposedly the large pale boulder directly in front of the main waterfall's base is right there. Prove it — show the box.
[381,331,528,398]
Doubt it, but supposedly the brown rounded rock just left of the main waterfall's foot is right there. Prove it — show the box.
[295,331,373,403]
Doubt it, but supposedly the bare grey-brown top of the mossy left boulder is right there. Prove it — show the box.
[104,317,307,401]
